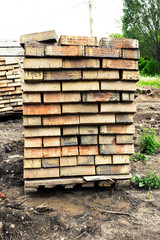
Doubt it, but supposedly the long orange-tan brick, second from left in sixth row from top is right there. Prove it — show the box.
[44,93,81,103]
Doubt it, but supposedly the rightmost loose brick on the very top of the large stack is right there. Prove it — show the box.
[99,38,139,48]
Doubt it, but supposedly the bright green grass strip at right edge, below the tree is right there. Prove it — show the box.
[136,76,160,89]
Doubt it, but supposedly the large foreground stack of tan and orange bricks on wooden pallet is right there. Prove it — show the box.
[21,32,139,191]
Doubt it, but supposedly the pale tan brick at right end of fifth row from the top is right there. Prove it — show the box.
[101,81,136,92]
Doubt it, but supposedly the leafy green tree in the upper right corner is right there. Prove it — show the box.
[122,0,160,72]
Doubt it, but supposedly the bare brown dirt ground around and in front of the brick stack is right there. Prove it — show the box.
[0,88,160,240]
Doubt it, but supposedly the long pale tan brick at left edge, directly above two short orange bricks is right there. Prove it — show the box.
[24,127,60,137]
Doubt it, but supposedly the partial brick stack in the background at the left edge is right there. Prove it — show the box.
[0,58,22,115]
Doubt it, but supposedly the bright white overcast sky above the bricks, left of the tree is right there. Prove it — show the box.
[0,0,123,40]
